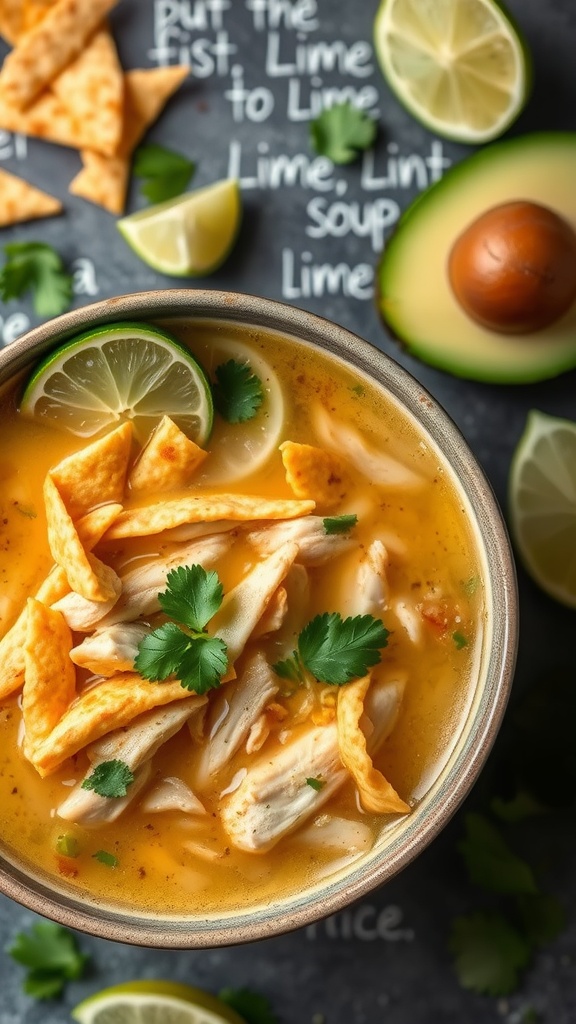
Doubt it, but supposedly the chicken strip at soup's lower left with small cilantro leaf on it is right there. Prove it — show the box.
[57,696,205,825]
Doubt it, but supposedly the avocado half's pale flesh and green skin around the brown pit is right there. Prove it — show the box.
[377,132,576,384]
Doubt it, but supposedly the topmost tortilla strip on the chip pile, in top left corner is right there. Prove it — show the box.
[0,0,118,111]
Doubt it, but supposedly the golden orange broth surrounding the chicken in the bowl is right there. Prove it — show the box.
[0,323,484,915]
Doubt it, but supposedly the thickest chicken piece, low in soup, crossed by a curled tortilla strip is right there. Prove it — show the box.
[221,681,404,853]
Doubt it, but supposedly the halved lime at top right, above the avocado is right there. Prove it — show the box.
[374,0,530,142]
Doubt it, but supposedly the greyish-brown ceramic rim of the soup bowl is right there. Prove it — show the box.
[0,289,519,949]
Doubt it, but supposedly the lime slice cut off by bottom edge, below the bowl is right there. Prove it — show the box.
[72,981,245,1024]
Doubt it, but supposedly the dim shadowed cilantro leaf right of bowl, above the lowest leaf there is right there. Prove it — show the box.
[458,814,538,895]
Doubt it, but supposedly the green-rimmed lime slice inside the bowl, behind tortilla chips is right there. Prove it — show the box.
[20,324,213,444]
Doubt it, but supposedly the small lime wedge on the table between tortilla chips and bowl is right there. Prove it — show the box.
[118,178,242,278]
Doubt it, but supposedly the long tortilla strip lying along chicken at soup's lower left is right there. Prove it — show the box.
[31,672,206,777]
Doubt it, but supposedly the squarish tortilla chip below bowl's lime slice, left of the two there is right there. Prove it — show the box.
[50,423,132,519]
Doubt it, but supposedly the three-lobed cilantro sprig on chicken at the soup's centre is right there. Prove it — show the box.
[134,565,228,693]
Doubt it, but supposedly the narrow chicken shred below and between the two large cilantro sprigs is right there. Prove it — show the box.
[195,650,278,791]
